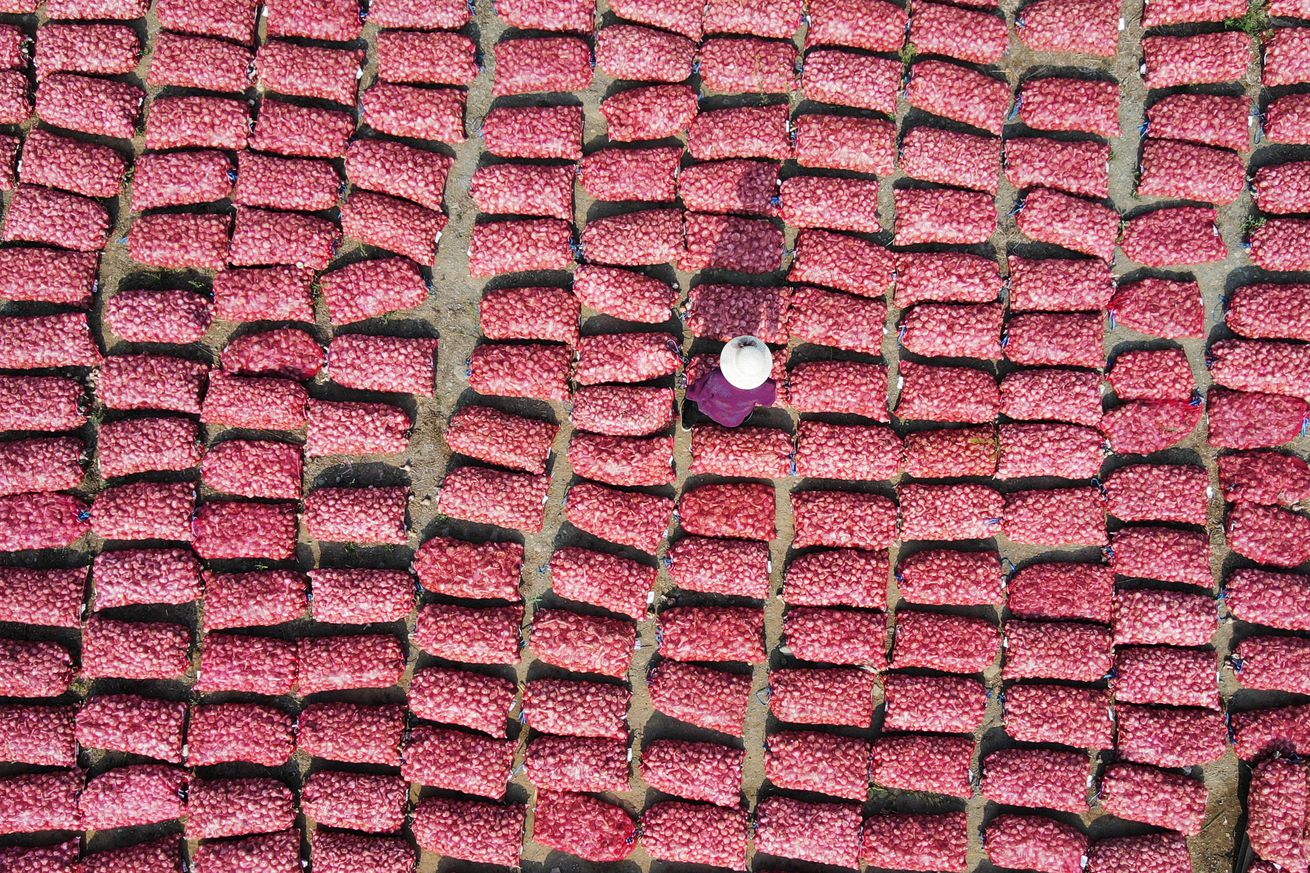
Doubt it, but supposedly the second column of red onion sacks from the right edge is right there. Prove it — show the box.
[1063,4,1250,864]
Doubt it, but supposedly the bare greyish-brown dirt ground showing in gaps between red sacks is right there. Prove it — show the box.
[0,0,1310,873]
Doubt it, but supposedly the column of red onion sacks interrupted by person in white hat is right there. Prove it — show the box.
[626,3,800,854]
